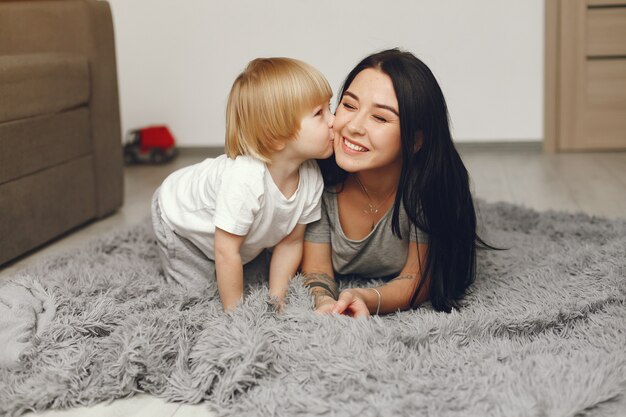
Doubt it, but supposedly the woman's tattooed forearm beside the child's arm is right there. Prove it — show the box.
[301,241,339,312]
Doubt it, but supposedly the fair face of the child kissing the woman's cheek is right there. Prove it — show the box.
[290,103,335,159]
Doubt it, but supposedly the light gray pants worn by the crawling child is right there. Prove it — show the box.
[152,189,269,290]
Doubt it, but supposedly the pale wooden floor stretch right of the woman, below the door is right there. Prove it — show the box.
[461,144,626,218]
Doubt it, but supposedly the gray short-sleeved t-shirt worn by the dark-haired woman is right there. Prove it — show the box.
[304,187,428,279]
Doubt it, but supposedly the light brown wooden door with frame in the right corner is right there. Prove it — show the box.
[544,0,626,151]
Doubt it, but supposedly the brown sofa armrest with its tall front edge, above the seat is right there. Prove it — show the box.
[0,0,124,217]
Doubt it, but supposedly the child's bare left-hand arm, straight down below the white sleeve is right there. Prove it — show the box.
[215,227,246,310]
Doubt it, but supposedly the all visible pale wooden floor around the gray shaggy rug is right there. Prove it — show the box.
[0,143,626,417]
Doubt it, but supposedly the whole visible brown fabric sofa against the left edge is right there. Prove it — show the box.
[0,0,123,264]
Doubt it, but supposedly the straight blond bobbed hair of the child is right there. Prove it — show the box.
[226,58,332,162]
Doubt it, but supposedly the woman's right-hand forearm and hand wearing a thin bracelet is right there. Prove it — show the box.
[332,242,430,317]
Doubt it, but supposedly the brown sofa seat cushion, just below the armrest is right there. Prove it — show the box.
[0,53,89,122]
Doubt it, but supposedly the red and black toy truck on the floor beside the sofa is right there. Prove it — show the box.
[124,125,177,164]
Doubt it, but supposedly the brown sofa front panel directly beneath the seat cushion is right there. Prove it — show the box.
[0,107,92,184]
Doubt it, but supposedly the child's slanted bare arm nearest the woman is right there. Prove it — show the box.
[270,224,306,302]
